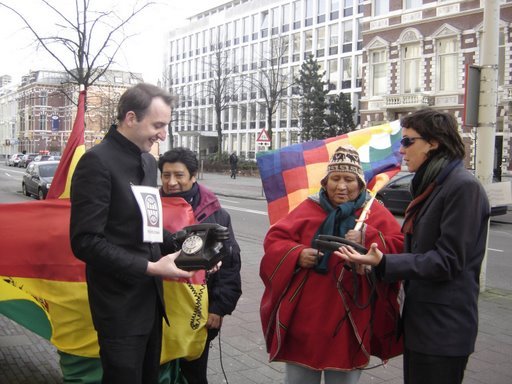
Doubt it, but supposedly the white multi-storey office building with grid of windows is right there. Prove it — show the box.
[167,0,363,159]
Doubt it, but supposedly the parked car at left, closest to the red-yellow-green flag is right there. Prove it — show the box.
[21,161,59,200]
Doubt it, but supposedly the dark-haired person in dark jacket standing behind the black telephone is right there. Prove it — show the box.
[158,147,242,384]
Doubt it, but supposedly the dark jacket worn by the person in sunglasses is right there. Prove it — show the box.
[383,165,490,356]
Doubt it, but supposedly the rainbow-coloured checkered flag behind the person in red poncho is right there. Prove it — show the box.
[257,120,402,224]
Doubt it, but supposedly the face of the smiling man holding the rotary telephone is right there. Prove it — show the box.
[124,97,171,152]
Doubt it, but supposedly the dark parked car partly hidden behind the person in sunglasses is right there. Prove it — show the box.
[376,172,508,216]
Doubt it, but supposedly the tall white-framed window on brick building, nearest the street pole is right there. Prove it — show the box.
[436,37,458,91]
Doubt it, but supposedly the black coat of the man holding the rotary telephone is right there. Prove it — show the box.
[70,129,176,336]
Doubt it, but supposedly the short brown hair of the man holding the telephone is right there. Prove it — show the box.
[117,83,175,122]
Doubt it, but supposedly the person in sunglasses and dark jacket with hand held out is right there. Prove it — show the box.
[335,109,490,384]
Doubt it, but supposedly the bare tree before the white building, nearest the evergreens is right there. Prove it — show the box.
[249,37,294,149]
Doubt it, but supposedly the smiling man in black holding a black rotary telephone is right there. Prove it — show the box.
[70,84,193,384]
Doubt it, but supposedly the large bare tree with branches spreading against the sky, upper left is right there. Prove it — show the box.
[0,0,154,89]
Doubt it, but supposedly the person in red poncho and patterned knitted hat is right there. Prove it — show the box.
[260,146,403,384]
